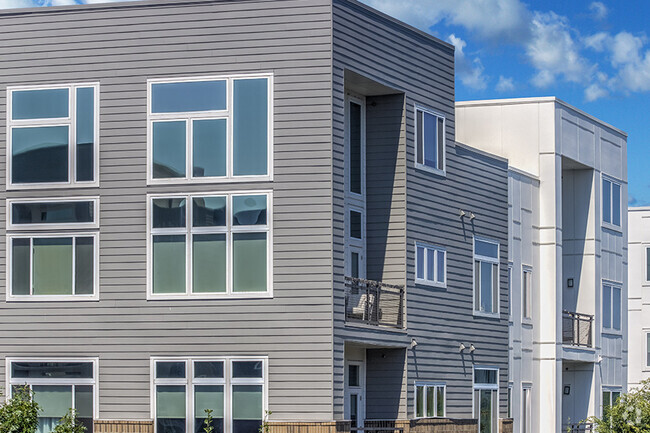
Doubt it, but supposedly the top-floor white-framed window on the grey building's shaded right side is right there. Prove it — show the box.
[415,105,446,174]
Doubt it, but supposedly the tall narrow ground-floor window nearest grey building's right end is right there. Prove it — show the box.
[474,367,499,433]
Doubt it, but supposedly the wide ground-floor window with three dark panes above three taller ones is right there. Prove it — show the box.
[151,357,268,433]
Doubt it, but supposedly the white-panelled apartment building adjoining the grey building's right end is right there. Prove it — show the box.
[456,98,628,433]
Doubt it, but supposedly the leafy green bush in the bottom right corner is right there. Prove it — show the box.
[587,379,650,433]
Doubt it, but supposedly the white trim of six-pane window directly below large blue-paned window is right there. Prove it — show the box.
[146,190,273,300]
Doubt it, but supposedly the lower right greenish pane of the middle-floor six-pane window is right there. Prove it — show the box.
[232,233,267,292]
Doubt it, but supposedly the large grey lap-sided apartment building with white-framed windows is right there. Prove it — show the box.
[0,0,512,433]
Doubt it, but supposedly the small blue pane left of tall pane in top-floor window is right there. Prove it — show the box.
[192,119,227,177]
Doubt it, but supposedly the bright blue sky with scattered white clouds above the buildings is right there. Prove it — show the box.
[0,0,650,206]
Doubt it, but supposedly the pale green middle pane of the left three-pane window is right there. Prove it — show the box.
[32,238,72,295]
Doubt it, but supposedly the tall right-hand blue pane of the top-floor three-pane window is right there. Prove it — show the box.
[233,78,269,176]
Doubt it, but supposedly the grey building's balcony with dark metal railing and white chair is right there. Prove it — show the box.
[345,277,404,328]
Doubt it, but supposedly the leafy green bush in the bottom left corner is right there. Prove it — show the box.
[0,386,40,433]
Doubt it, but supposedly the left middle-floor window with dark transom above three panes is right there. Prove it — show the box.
[7,198,99,301]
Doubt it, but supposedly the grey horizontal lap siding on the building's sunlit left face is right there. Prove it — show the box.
[0,0,332,420]
